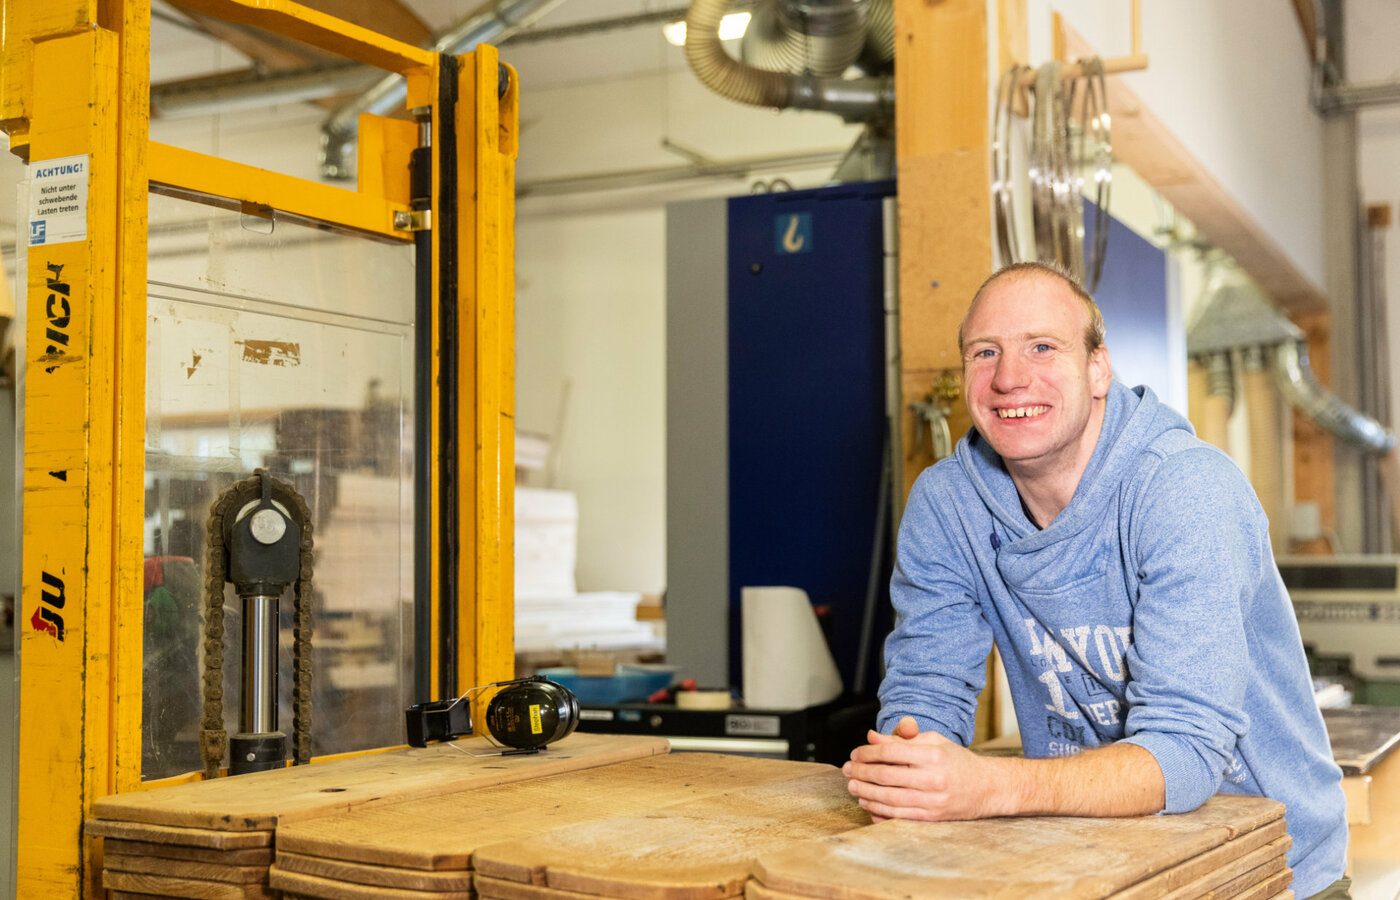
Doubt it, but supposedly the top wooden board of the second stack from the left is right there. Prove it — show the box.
[277,753,830,869]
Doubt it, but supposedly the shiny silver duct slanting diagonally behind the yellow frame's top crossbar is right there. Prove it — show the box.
[321,0,563,181]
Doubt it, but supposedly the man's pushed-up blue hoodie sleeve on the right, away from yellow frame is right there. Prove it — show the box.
[1126,448,1271,813]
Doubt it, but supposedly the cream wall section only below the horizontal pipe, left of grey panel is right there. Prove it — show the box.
[515,209,665,592]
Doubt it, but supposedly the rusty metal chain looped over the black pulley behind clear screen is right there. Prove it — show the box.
[199,474,314,778]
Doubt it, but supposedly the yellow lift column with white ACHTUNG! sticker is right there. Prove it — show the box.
[0,0,150,897]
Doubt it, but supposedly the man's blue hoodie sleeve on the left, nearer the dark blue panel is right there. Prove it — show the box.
[876,469,991,746]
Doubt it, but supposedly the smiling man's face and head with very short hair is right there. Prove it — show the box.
[963,273,1112,476]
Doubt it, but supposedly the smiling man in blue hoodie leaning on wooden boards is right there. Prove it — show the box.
[844,263,1348,899]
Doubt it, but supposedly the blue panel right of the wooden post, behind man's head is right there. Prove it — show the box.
[1084,200,1184,400]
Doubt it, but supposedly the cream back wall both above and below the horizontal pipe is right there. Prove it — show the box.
[503,45,858,592]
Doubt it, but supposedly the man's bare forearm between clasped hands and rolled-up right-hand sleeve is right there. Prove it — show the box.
[1000,743,1166,816]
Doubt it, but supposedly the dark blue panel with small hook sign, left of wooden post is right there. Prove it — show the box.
[715,182,895,687]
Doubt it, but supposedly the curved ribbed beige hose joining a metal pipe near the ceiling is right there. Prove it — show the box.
[686,0,895,122]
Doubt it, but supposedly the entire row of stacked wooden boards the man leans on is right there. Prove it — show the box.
[90,735,1292,900]
